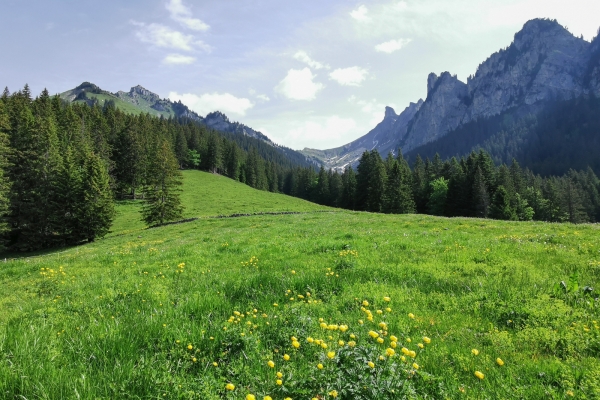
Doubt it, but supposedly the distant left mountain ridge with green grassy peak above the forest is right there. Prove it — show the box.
[60,82,313,166]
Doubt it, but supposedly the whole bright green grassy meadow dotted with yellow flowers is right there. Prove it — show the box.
[0,172,600,400]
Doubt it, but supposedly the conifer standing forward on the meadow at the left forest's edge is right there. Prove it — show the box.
[142,139,183,226]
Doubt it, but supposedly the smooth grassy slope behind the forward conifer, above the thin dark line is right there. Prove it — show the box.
[110,171,330,236]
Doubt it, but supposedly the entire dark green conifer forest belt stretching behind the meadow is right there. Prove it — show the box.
[0,85,600,251]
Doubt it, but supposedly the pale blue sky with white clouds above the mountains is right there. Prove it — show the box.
[0,0,600,149]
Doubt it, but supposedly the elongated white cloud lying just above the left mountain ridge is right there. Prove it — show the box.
[169,92,254,117]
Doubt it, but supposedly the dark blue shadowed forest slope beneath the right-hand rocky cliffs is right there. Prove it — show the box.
[405,96,600,176]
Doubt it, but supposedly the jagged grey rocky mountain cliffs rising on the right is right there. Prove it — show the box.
[303,19,600,168]
